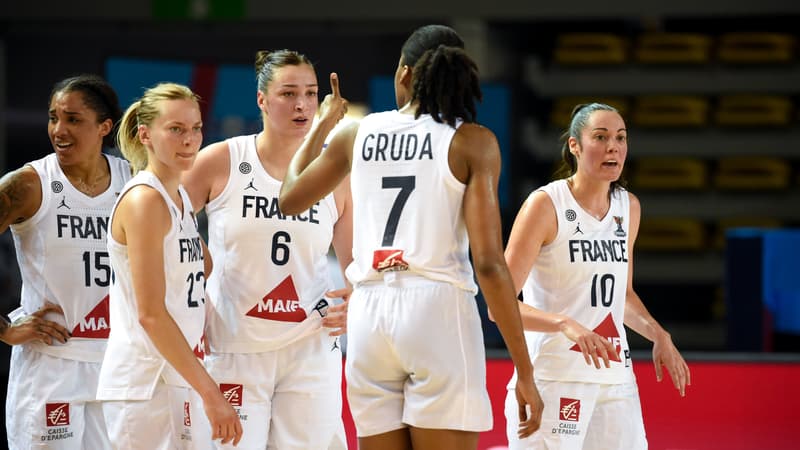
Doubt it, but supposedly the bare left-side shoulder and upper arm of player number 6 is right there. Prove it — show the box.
[181,141,231,212]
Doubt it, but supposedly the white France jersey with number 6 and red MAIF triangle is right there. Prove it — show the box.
[206,135,339,353]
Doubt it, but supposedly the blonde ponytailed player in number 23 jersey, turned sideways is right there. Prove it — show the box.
[98,83,242,449]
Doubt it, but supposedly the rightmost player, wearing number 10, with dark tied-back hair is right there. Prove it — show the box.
[506,103,690,450]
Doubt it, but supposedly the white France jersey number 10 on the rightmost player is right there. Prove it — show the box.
[522,180,631,384]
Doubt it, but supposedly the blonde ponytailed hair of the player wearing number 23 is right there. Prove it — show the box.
[117,83,200,174]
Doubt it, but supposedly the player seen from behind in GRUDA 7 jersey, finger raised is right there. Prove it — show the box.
[280,25,542,450]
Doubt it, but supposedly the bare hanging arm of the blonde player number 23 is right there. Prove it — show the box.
[111,186,241,442]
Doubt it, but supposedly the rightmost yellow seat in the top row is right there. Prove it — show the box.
[717,32,795,64]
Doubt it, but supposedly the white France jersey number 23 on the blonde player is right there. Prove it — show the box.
[98,171,206,400]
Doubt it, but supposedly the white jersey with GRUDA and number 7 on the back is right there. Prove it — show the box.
[347,111,477,293]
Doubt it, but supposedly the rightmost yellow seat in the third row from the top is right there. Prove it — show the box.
[714,156,791,190]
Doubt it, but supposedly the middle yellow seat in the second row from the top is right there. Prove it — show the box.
[632,95,708,127]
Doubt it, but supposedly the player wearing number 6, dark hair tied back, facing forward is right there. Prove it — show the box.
[184,50,353,450]
